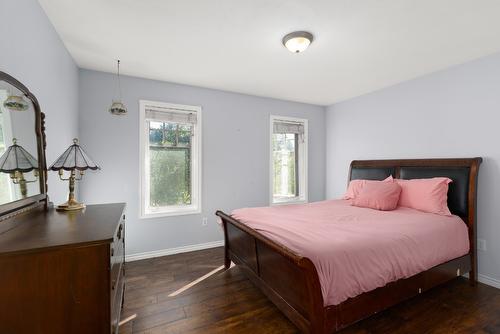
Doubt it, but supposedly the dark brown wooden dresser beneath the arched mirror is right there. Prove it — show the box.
[0,203,125,334]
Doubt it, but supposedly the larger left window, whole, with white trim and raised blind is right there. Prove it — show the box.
[140,101,201,218]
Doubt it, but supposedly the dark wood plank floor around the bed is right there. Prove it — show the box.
[121,248,500,334]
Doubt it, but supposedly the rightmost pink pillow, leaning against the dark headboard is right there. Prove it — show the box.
[396,177,452,216]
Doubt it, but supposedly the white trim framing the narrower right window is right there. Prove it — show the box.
[269,115,309,206]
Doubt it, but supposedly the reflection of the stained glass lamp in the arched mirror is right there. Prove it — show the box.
[0,138,38,198]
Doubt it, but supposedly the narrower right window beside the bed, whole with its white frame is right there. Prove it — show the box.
[270,116,307,204]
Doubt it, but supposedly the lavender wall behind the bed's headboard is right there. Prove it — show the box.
[326,54,500,287]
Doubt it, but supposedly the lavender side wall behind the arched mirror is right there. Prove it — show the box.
[0,0,78,203]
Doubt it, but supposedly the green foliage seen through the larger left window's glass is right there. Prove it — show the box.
[149,121,193,207]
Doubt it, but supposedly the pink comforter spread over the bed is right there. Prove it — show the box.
[232,200,469,306]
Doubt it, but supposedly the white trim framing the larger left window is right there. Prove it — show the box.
[139,100,202,219]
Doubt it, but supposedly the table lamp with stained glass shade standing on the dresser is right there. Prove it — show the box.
[49,138,101,211]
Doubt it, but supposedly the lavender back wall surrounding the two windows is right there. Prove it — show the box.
[80,70,325,255]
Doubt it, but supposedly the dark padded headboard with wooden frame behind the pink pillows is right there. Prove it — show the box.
[349,158,482,220]
